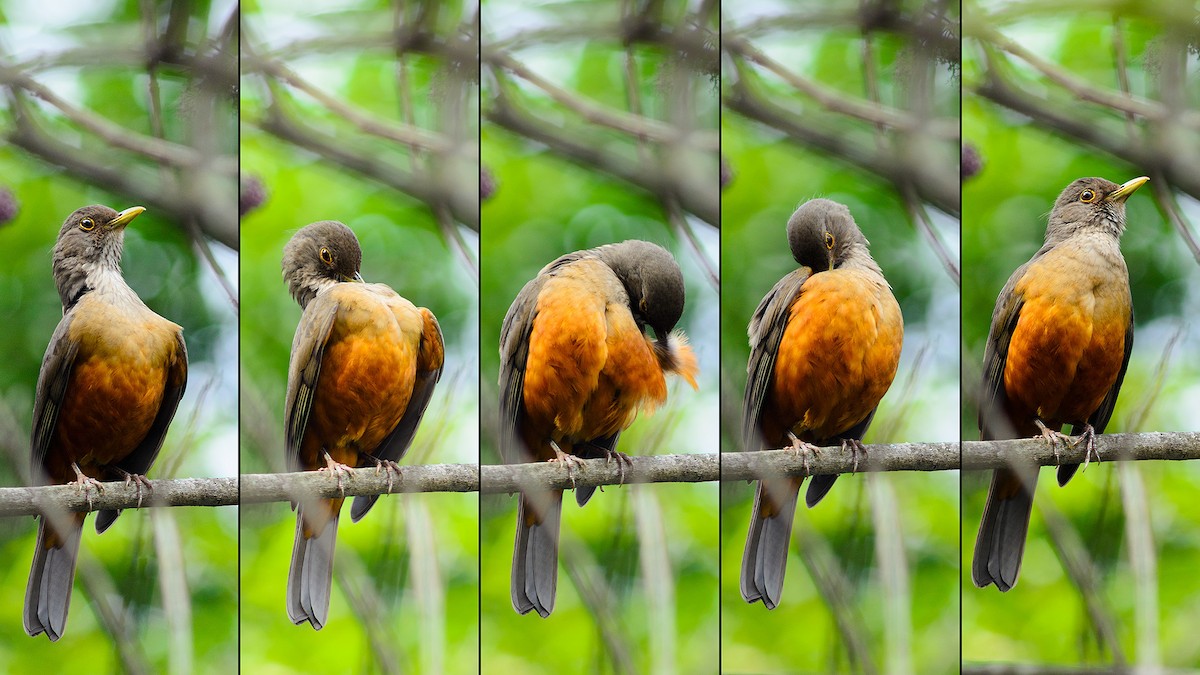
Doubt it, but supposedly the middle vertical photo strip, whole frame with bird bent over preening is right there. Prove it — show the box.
[480,0,720,673]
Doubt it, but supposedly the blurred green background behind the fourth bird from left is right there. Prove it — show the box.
[720,2,959,673]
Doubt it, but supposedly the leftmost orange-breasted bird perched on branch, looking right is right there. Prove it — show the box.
[24,204,187,641]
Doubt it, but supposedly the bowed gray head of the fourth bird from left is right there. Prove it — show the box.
[787,199,880,274]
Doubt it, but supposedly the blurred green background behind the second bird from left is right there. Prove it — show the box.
[240,0,479,673]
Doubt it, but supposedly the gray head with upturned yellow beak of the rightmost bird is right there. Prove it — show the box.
[1046,175,1150,244]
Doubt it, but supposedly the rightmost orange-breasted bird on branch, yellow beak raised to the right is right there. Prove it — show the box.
[971,177,1150,591]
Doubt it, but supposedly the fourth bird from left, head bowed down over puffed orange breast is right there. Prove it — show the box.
[740,199,904,609]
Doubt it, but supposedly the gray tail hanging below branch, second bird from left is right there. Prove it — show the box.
[288,510,337,631]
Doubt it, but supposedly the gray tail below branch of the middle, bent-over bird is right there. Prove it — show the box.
[511,491,563,619]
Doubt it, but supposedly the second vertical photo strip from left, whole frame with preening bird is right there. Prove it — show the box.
[240,2,479,673]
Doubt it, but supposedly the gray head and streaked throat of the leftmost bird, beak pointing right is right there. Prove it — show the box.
[52,204,145,309]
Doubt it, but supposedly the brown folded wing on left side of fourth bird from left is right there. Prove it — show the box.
[742,268,810,450]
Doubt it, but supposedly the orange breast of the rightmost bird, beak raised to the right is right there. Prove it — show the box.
[1004,249,1133,429]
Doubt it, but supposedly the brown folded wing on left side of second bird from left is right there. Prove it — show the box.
[284,293,337,471]
